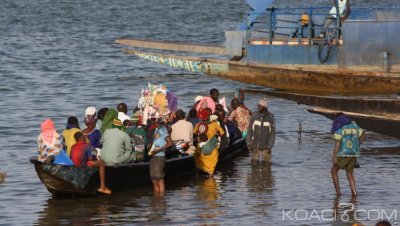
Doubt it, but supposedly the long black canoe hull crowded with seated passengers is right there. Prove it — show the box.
[30,139,247,196]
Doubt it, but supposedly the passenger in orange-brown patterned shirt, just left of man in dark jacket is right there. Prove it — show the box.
[228,98,251,137]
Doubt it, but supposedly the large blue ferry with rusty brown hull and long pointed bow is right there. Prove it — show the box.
[116,0,400,95]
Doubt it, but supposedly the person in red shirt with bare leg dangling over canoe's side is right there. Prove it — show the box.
[71,132,111,195]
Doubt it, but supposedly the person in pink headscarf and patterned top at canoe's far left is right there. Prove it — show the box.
[37,119,63,163]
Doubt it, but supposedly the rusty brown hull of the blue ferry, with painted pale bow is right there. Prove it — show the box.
[126,50,400,95]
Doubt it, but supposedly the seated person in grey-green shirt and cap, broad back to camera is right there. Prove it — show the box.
[100,119,136,165]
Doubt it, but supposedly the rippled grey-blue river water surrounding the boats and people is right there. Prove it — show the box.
[0,0,400,225]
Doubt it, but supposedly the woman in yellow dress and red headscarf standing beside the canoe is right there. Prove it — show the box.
[193,109,224,177]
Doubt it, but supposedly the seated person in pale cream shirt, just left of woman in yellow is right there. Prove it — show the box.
[171,109,196,155]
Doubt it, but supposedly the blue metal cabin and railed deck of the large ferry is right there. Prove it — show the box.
[225,6,400,73]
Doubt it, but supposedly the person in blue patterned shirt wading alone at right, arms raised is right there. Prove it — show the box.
[331,113,365,196]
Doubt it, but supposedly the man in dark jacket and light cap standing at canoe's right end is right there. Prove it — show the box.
[246,98,275,163]
